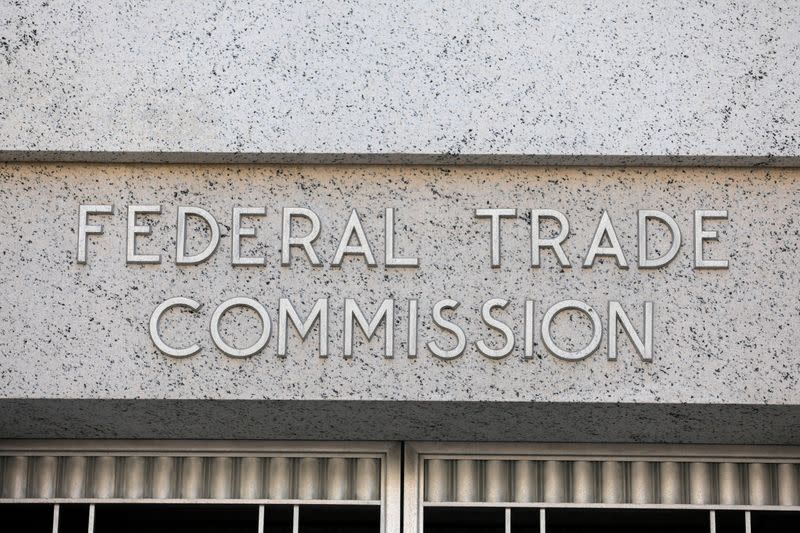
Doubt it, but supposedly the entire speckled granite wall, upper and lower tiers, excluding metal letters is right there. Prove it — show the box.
[0,0,800,444]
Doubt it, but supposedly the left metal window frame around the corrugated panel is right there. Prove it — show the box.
[0,439,402,533]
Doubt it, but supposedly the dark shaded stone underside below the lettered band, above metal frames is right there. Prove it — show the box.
[0,398,800,446]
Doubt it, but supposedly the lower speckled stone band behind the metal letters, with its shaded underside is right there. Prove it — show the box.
[0,164,800,442]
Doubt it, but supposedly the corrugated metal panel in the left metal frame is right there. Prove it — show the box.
[0,455,381,503]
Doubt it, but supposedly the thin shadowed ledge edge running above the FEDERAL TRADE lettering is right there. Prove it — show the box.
[0,150,800,167]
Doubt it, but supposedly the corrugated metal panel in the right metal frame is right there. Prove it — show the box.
[424,458,800,506]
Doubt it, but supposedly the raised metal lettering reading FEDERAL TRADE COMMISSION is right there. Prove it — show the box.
[77,204,728,361]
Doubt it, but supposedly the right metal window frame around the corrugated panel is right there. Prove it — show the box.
[403,441,800,533]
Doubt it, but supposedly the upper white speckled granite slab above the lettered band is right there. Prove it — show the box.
[0,0,800,166]
